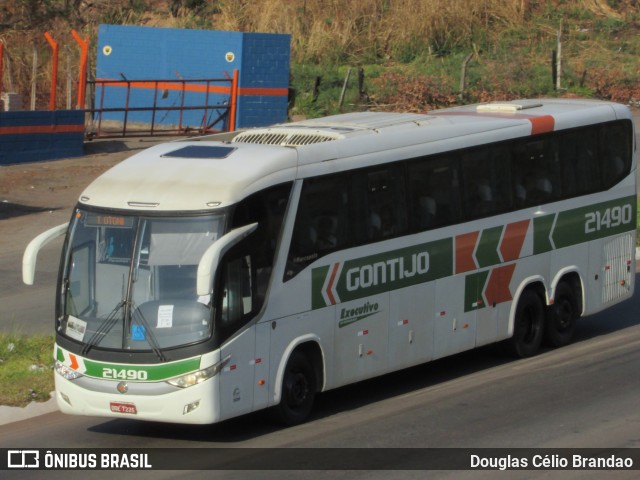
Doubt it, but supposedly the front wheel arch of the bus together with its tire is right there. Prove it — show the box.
[273,341,324,426]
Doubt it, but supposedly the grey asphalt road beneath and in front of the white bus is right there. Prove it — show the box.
[0,275,640,479]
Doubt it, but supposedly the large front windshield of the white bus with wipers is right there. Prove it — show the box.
[58,209,225,357]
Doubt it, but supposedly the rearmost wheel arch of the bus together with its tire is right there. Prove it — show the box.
[544,272,583,348]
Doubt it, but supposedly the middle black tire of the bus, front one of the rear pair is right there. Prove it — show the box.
[507,289,545,358]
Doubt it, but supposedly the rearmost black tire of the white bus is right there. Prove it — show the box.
[544,282,579,348]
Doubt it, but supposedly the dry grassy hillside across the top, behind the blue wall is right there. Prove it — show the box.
[0,0,640,108]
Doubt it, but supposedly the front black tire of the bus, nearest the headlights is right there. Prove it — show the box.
[275,350,316,426]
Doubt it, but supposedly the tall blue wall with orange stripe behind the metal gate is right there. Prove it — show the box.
[96,25,290,129]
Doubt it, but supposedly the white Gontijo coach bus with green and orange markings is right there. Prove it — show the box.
[23,99,637,424]
